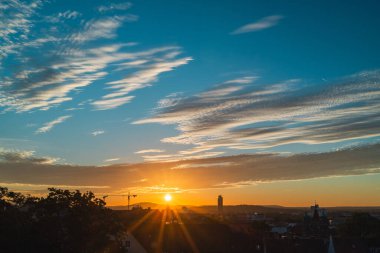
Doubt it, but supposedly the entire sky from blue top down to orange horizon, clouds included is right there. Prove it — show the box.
[0,0,380,206]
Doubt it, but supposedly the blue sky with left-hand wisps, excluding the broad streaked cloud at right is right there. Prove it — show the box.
[0,1,380,165]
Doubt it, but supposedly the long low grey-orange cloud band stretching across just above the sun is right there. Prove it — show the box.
[0,143,380,192]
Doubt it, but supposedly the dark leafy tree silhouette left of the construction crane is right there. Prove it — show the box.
[0,187,124,253]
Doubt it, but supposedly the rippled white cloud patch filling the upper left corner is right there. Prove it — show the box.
[0,0,190,112]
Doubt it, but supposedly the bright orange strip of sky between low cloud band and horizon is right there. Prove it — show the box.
[101,175,380,207]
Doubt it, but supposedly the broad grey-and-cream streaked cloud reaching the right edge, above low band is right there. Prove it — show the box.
[134,71,380,160]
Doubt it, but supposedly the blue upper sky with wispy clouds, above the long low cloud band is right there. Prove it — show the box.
[0,0,380,206]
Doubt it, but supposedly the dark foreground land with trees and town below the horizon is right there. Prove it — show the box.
[0,187,380,253]
